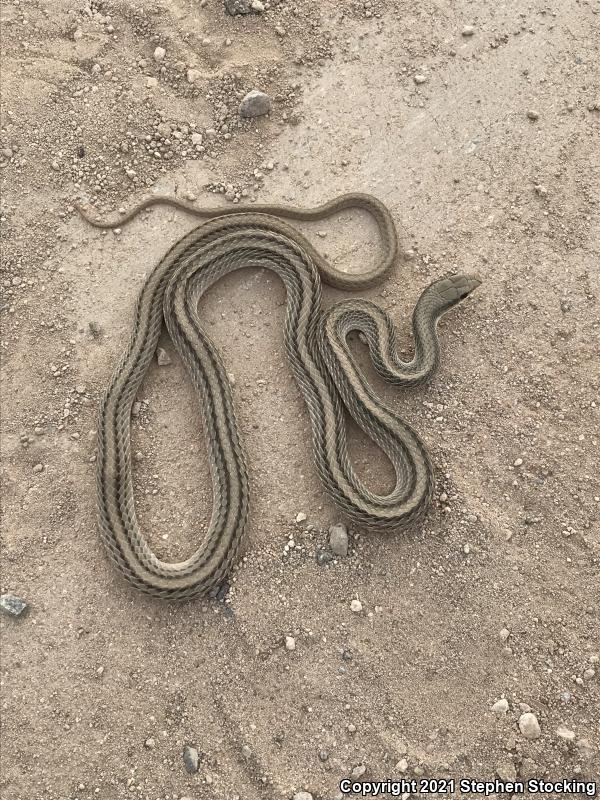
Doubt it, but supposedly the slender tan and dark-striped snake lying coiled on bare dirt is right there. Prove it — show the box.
[77,193,481,600]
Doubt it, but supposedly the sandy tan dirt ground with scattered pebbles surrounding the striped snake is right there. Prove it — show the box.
[0,0,600,800]
